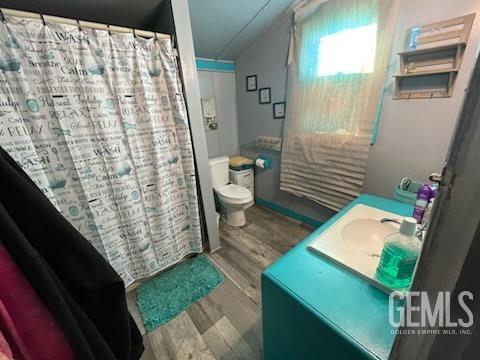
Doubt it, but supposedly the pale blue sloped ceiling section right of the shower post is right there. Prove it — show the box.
[189,0,294,60]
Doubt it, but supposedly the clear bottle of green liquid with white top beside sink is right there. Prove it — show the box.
[376,217,422,289]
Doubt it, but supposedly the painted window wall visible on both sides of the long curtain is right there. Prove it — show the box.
[235,0,480,218]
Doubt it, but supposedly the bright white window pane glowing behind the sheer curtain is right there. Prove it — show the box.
[317,23,377,76]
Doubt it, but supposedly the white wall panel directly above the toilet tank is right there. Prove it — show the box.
[198,70,239,158]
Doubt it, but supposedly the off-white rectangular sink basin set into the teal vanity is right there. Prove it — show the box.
[308,204,403,292]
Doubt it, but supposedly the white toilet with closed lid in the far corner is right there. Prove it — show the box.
[209,156,253,226]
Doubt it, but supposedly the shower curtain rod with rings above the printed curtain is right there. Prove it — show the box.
[0,8,172,39]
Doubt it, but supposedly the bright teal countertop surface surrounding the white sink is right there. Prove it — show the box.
[263,194,413,359]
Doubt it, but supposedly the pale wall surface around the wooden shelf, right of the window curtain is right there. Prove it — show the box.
[363,0,480,197]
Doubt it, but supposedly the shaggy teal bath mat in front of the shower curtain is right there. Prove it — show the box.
[136,255,223,331]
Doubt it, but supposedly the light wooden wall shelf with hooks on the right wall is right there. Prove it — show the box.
[394,14,475,99]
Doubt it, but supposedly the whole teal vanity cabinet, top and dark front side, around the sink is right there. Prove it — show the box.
[262,195,413,360]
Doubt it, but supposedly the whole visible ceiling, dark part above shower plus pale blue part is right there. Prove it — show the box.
[0,0,295,60]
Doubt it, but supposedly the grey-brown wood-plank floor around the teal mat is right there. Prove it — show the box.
[127,205,313,360]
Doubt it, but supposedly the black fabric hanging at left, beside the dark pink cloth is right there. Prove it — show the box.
[0,148,143,360]
